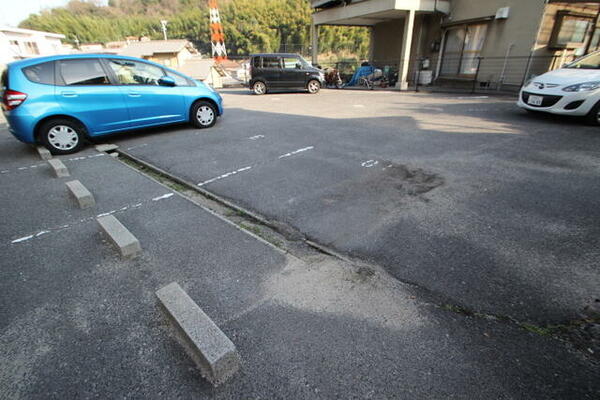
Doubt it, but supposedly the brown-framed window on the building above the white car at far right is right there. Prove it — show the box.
[550,10,594,49]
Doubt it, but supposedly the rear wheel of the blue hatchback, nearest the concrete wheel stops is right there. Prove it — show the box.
[39,118,85,155]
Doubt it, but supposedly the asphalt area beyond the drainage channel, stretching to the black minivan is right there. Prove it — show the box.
[111,90,600,322]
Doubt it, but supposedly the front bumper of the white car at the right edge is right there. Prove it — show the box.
[517,87,600,116]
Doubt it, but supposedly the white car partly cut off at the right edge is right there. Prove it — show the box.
[517,52,600,125]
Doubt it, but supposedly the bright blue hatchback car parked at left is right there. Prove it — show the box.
[2,54,223,154]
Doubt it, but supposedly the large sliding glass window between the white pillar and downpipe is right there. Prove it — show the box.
[441,24,487,76]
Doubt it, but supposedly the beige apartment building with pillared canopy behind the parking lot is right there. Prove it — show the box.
[311,0,600,89]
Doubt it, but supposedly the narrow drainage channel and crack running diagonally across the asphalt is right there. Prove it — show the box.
[108,149,600,362]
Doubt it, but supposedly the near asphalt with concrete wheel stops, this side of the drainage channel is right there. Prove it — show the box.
[0,119,600,399]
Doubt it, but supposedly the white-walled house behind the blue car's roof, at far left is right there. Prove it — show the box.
[0,26,65,68]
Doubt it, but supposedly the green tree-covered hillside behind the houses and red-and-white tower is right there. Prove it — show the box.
[20,0,369,58]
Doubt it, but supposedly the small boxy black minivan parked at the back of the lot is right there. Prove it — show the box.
[250,53,325,94]
